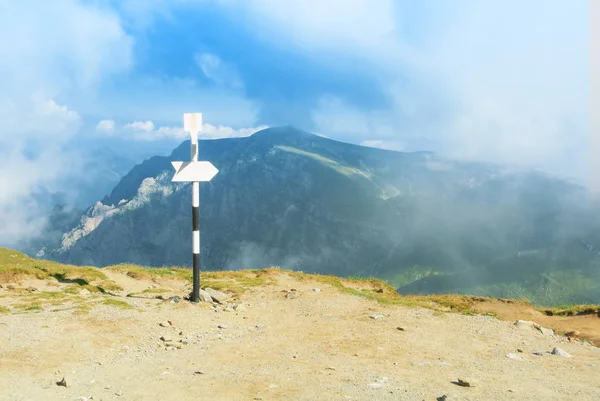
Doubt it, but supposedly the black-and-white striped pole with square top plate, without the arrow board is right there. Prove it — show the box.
[184,113,202,303]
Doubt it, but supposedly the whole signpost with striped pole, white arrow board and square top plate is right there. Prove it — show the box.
[171,113,219,303]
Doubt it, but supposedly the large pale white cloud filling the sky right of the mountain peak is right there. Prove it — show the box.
[308,0,589,179]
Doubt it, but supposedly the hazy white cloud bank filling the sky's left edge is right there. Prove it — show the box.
[0,0,132,246]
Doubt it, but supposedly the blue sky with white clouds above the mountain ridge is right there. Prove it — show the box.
[0,0,590,242]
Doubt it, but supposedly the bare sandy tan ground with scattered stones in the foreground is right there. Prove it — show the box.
[0,274,600,401]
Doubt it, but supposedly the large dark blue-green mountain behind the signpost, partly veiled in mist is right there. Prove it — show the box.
[44,127,600,303]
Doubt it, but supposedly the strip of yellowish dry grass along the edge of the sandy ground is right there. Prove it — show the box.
[0,248,600,316]
